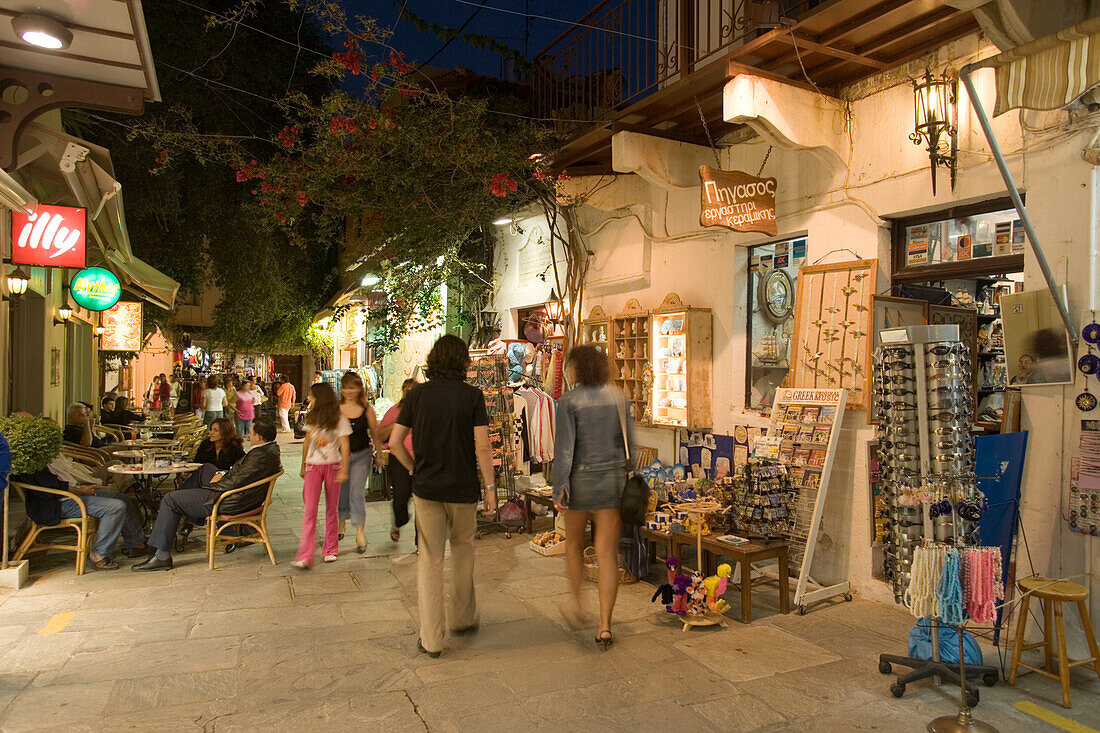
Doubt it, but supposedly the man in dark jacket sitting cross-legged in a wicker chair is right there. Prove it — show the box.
[131,417,283,572]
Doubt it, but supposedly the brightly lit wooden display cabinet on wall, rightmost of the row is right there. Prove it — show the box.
[650,293,714,429]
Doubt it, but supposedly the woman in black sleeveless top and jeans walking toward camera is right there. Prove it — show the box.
[339,372,378,555]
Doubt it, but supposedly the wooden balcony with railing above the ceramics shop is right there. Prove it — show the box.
[531,0,978,175]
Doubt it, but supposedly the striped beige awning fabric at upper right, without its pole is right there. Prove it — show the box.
[975,17,1100,117]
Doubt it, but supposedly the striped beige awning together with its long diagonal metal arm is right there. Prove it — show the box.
[959,17,1100,344]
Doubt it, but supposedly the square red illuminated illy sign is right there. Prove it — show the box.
[11,204,87,267]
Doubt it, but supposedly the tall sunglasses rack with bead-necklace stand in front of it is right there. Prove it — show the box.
[873,326,1003,731]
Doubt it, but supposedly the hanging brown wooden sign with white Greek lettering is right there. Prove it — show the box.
[699,165,779,236]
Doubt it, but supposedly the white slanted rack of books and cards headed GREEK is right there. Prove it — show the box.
[768,387,851,615]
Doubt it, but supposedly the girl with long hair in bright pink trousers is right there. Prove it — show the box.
[290,382,351,570]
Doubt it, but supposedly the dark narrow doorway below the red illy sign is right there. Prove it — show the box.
[8,291,46,415]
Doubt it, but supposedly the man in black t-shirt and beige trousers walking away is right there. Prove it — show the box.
[389,335,496,657]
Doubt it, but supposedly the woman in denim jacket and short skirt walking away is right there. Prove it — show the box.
[553,344,633,649]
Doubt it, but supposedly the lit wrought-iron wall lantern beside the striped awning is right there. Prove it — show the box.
[909,69,959,195]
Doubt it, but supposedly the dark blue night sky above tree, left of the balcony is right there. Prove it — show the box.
[341,0,597,76]
